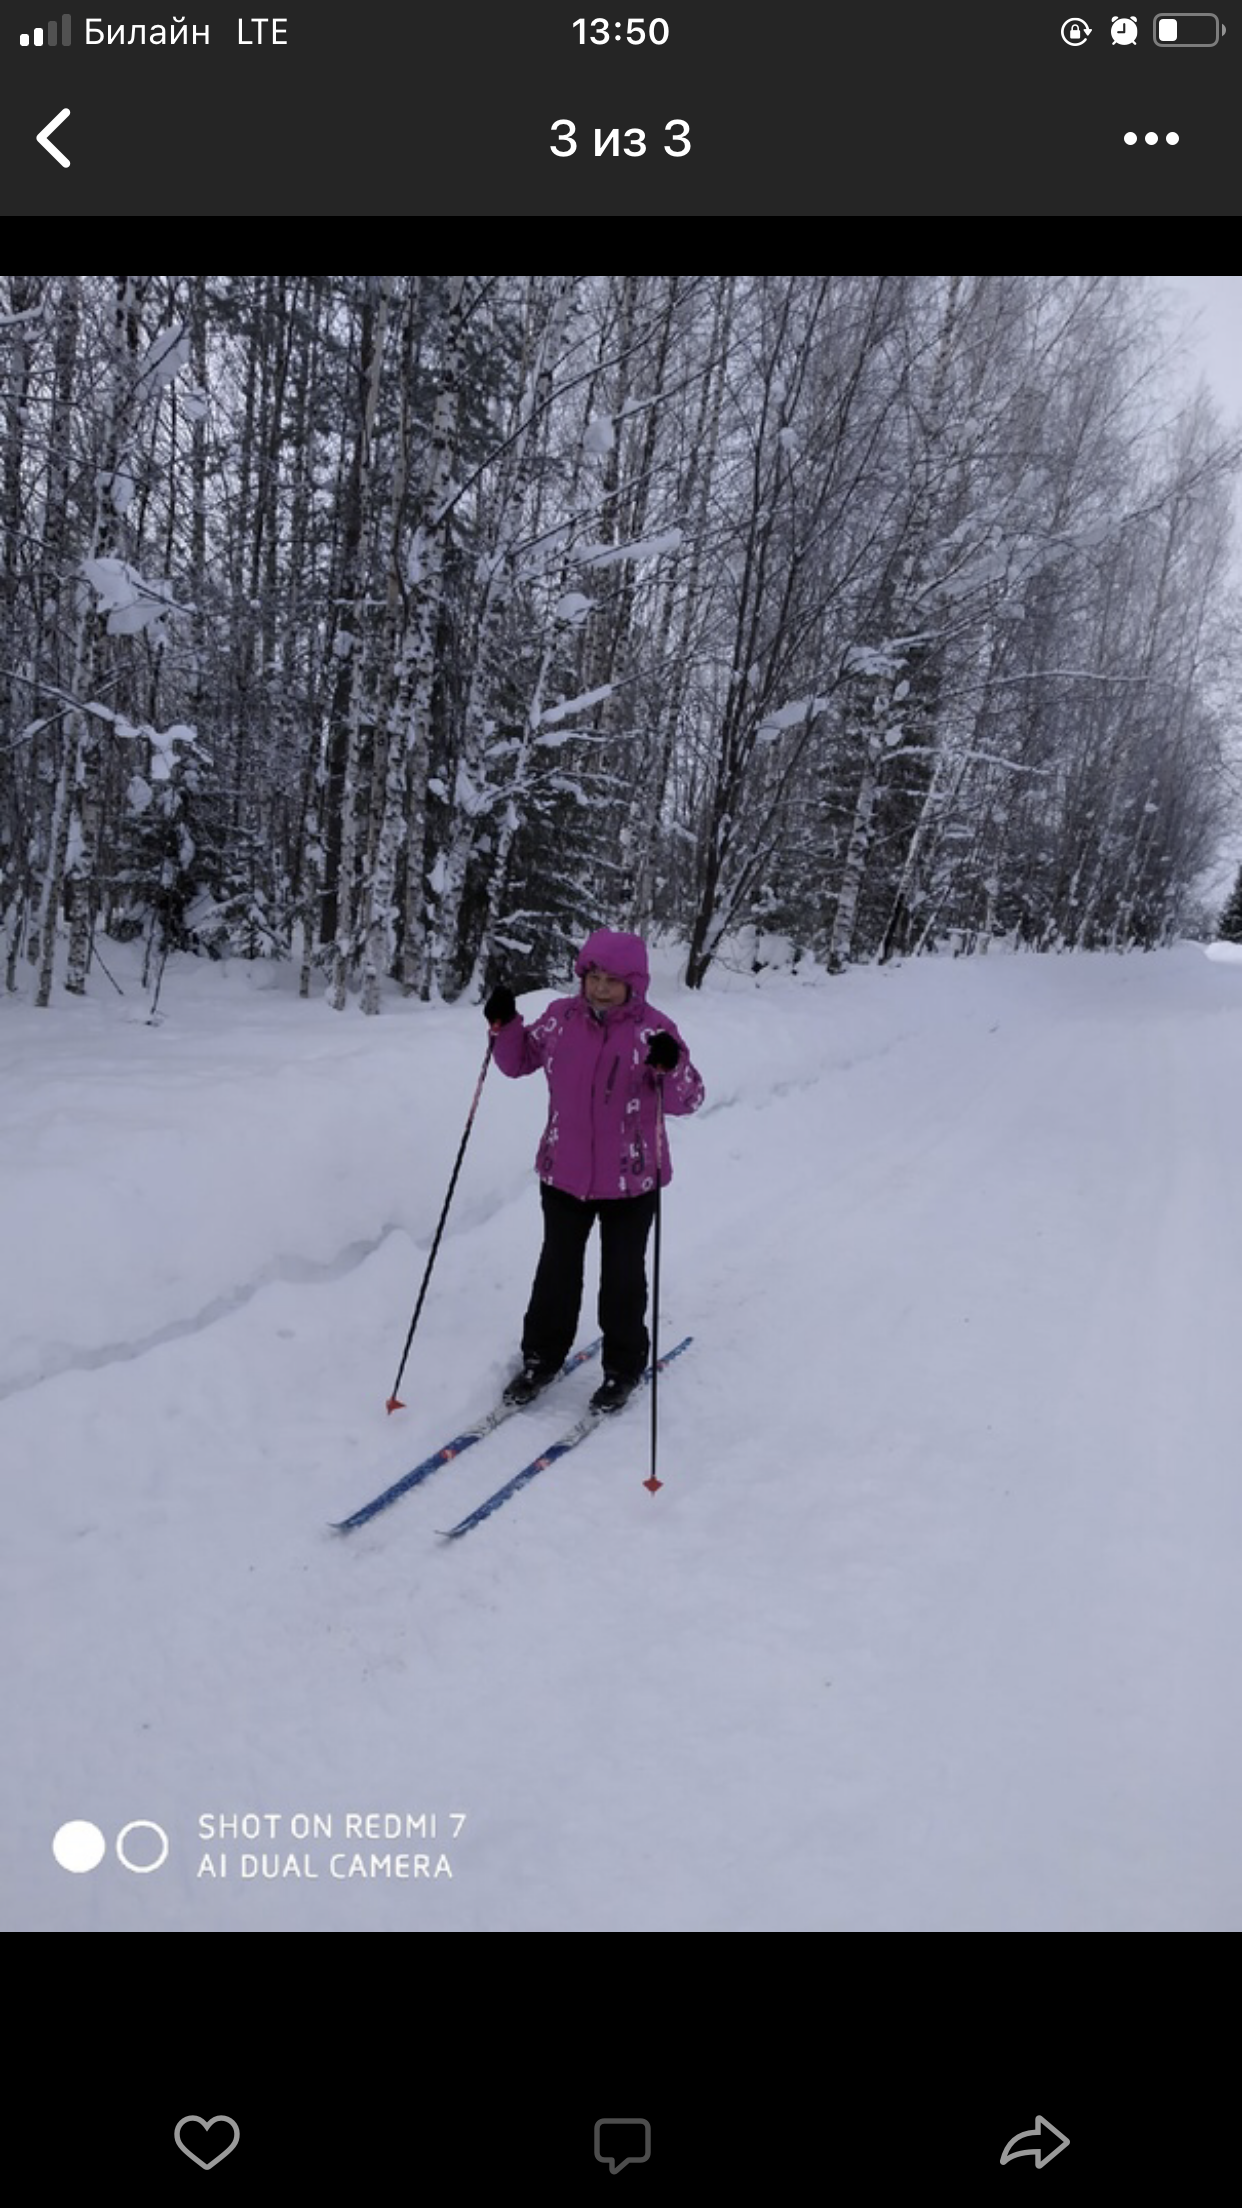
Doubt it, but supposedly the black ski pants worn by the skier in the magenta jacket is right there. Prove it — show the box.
[522,1181,656,1380]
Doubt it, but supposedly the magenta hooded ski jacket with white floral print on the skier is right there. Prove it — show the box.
[493,927,703,1201]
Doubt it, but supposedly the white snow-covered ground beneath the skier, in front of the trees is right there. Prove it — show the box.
[0,945,1242,1930]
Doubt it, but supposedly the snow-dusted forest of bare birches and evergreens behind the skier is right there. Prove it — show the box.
[0,276,1242,1013]
